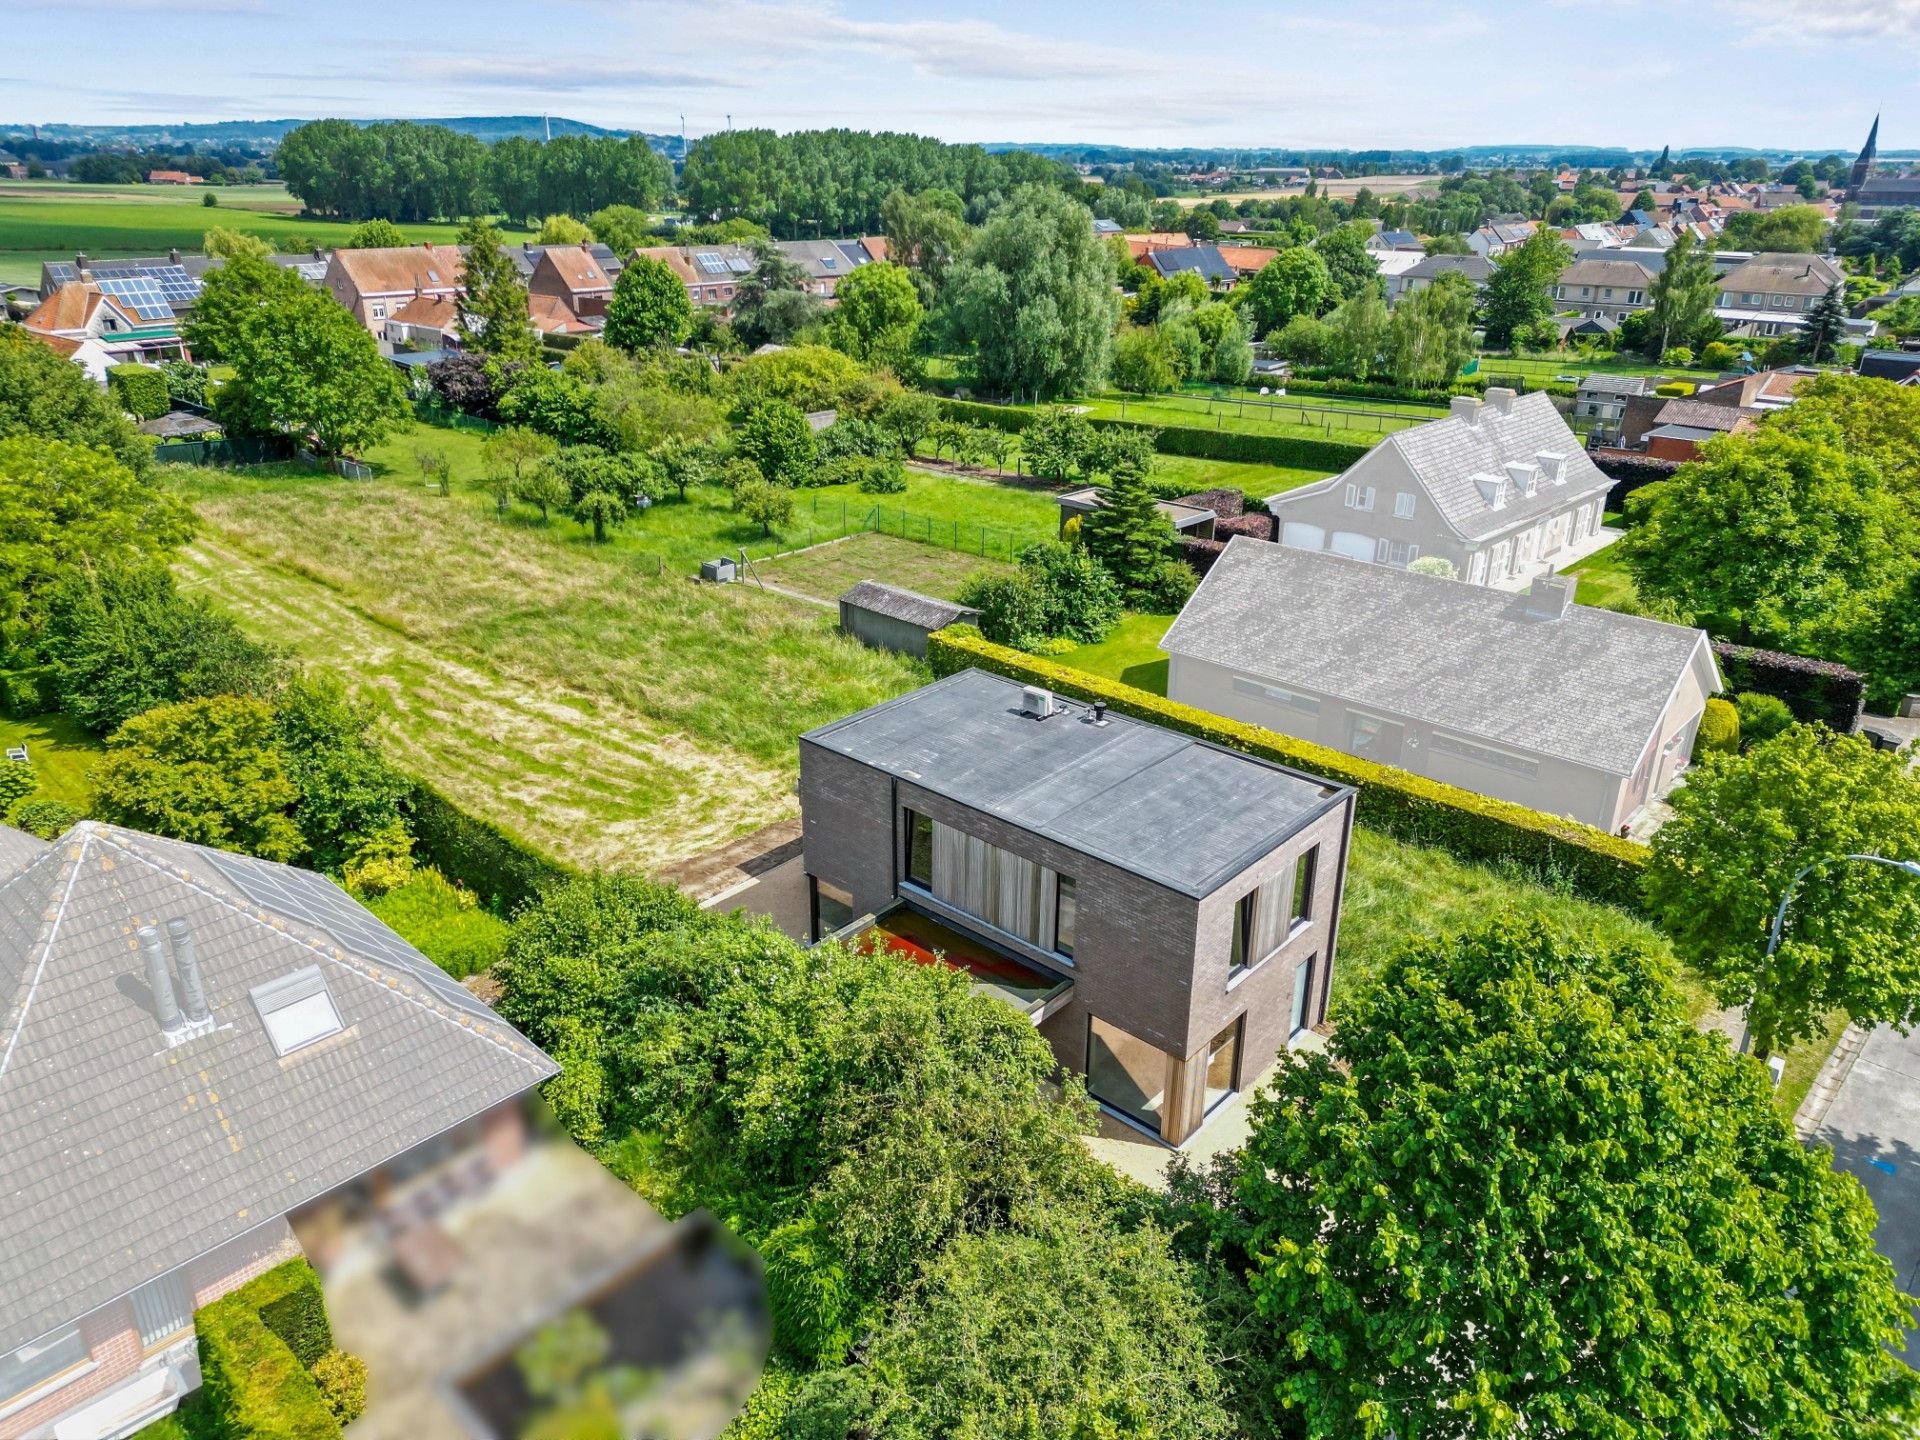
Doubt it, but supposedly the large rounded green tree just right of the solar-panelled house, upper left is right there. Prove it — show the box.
[215,284,407,455]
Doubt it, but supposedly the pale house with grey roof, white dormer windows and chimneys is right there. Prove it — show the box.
[1267,386,1615,589]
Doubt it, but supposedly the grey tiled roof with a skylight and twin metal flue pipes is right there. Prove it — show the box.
[0,822,557,1354]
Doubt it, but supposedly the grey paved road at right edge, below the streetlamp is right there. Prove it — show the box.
[1812,1025,1920,1365]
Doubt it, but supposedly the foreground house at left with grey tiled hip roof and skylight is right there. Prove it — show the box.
[0,822,559,1440]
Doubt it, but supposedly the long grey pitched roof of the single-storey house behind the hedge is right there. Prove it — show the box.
[1160,538,1716,776]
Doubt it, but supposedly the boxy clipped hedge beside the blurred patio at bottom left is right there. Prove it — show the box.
[194,1260,340,1440]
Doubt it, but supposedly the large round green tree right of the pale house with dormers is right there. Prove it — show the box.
[1619,426,1920,655]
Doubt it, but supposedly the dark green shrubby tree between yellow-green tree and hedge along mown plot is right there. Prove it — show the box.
[273,672,413,874]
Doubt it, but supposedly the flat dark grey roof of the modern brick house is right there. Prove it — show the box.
[801,670,1348,897]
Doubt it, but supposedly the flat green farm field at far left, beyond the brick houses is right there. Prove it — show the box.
[0,180,530,284]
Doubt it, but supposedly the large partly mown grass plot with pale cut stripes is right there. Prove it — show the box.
[169,468,927,872]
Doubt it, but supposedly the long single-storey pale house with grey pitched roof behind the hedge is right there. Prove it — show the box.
[1160,540,1720,829]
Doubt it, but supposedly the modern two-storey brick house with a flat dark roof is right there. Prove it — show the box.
[801,668,1354,1144]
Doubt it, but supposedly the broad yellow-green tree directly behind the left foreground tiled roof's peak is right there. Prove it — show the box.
[90,695,305,860]
